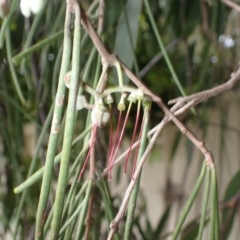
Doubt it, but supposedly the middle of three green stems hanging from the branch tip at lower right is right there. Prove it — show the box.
[197,167,211,240]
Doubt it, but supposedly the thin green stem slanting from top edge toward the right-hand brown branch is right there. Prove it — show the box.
[144,0,186,96]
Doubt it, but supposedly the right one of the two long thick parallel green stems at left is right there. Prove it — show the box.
[51,1,81,239]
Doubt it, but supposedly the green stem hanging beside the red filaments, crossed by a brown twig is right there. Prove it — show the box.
[124,101,151,240]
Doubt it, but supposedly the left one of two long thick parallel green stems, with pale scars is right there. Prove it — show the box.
[35,4,71,240]
